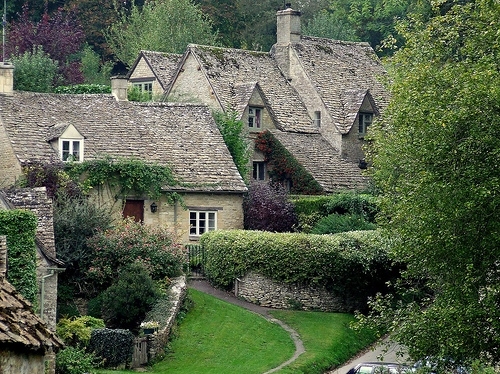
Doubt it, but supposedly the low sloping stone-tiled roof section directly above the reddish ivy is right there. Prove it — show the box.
[272,130,368,192]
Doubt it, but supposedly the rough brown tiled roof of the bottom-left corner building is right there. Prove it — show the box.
[0,278,64,354]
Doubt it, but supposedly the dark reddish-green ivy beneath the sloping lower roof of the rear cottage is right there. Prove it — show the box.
[255,131,323,195]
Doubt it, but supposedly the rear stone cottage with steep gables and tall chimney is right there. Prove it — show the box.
[128,7,388,193]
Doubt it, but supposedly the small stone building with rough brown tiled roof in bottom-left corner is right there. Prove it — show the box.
[0,236,63,374]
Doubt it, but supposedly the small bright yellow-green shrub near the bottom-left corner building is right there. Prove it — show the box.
[56,316,104,348]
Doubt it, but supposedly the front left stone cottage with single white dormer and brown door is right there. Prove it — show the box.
[0,70,247,243]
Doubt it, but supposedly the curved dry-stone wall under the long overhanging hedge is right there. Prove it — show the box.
[234,272,352,312]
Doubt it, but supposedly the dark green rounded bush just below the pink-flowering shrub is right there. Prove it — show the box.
[102,263,160,331]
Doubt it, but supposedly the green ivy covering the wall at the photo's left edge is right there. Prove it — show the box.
[0,209,38,308]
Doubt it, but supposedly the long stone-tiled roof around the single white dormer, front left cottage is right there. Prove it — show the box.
[0,92,246,192]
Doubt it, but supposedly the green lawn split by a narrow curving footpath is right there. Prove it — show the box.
[95,289,370,374]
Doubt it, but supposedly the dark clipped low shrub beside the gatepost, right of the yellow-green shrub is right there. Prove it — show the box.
[87,329,134,368]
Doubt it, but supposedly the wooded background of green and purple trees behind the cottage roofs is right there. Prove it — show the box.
[2,0,436,87]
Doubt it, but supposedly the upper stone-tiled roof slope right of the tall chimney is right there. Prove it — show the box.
[293,36,389,134]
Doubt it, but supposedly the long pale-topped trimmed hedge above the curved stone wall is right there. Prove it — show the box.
[200,230,400,308]
